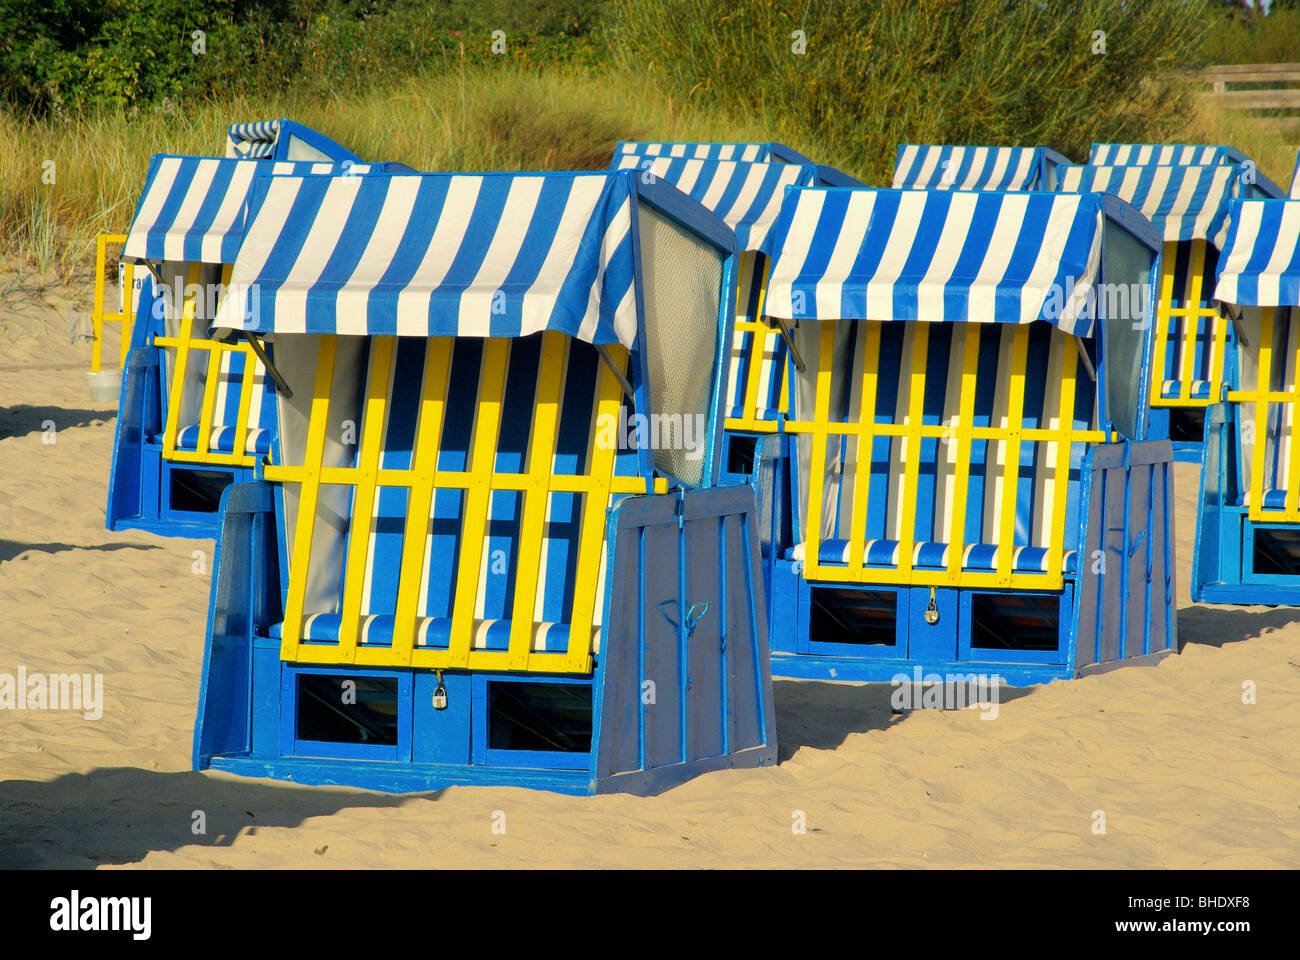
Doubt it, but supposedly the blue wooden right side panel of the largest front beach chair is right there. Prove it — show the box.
[597,484,776,793]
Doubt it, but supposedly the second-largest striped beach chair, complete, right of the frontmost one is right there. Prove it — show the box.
[764,187,1175,684]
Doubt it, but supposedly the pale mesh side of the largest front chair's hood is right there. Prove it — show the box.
[638,204,723,487]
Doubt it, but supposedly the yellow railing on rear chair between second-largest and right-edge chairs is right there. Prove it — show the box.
[1151,239,1230,407]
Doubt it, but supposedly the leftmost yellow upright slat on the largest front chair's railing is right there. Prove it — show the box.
[280,337,338,661]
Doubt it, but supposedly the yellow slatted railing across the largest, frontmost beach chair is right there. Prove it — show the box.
[265,332,667,674]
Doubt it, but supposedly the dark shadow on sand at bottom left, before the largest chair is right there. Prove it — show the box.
[0,766,439,869]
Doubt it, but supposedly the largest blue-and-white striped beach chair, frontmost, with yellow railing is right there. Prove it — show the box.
[194,166,775,793]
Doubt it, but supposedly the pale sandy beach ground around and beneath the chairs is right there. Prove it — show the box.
[0,274,1300,868]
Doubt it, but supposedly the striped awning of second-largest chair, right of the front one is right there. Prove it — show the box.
[763,187,1102,337]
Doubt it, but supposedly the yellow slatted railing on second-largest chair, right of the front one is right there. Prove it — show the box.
[785,320,1105,589]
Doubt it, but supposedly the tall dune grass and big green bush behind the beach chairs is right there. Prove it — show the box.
[0,0,1300,291]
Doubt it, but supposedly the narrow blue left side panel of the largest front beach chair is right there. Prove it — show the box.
[194,484,280,770]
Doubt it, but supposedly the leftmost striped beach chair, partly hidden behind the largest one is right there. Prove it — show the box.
[107,121,406,537]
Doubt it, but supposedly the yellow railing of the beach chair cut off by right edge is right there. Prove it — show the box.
[1227,307,1300,523]
